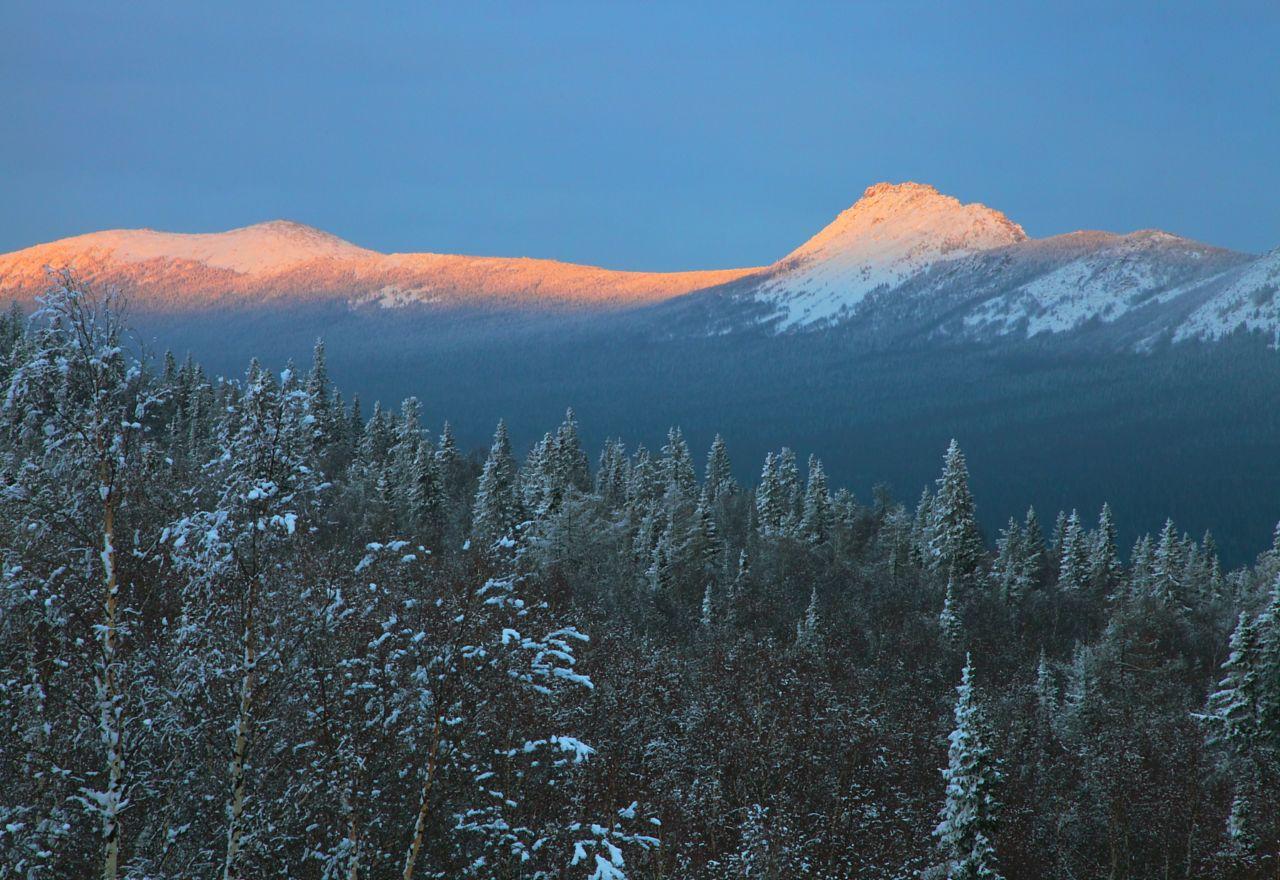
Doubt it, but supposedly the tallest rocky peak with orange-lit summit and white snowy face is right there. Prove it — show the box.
[755,183,1027,330]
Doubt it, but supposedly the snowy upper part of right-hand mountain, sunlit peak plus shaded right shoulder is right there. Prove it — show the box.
[692,183,1280,348]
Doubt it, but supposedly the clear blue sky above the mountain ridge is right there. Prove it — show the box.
[0,0,1280,270]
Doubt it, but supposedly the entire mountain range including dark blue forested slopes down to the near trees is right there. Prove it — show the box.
[0,183,1280,562]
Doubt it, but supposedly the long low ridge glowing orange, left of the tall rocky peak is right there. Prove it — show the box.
[0,220,756,311]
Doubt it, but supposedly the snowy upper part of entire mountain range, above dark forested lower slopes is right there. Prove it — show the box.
[0,183,1280,349]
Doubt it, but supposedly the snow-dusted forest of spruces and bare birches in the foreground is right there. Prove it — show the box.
[0,278,1280,880]
